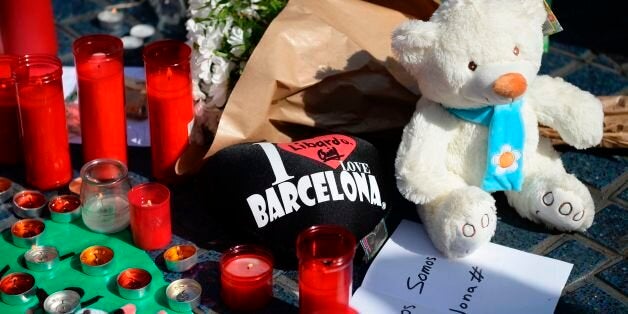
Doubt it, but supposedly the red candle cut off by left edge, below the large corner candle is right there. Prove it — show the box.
[0,55,22,165]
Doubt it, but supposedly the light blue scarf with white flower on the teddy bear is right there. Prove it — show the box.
[447,99,525,192]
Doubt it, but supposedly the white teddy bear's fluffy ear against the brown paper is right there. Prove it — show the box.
[392,20,438,66]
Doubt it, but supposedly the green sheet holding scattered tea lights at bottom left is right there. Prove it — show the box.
[0,219,172,313]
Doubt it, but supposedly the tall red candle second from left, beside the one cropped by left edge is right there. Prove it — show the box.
[11,55,72,190]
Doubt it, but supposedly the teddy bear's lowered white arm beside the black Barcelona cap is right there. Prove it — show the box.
[395,103,467,204]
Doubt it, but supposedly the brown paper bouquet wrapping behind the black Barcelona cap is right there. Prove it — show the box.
[177,0,438,173]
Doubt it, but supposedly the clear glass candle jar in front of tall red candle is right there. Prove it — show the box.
[81,158,131,233]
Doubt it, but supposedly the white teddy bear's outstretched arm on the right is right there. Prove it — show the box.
[527,75,604,149]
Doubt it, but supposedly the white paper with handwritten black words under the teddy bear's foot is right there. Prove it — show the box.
[351,220,573,314]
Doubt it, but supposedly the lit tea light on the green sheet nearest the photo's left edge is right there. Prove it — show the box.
[0,273,37,305]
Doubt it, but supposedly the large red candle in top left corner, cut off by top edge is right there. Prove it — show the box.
[0,0,57,55]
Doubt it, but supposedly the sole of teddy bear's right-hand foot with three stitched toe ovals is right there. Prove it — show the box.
[534,189,594,231]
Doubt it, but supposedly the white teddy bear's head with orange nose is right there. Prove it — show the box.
[392,0,547,109]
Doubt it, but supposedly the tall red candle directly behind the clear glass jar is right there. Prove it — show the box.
[72,35,127,165]
